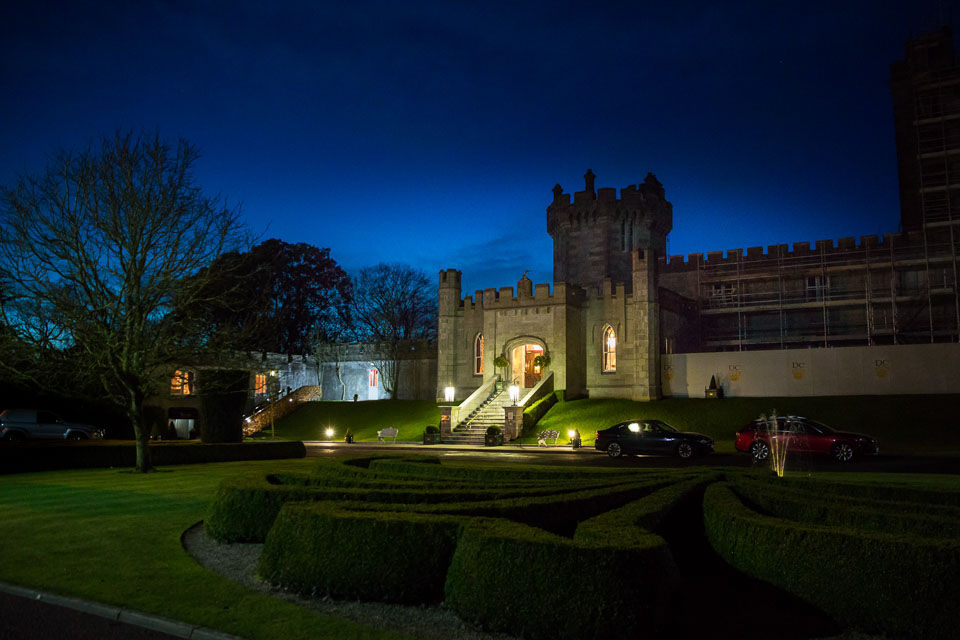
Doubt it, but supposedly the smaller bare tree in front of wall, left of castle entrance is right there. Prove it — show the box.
[351,263,437,397]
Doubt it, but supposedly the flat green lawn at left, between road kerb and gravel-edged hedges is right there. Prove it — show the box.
[0,460,400,640]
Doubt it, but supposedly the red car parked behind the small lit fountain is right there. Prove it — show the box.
[736,416,880,462]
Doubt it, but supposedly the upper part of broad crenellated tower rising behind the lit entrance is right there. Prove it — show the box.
[547,169,673,288]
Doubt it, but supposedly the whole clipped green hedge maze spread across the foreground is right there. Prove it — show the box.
[205,457,960,638]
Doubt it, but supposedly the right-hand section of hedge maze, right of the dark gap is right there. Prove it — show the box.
[703,475,960,638]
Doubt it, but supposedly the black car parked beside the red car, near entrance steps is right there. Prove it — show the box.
[593,420,713,458]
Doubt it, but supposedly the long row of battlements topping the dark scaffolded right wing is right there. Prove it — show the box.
[659,232,923,273]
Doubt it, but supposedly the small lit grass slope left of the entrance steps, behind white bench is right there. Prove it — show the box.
[261,400,440,441]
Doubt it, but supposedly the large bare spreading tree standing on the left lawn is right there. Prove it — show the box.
[0,133,248,471]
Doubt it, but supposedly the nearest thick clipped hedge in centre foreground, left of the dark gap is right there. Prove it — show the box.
[253,474,707,638]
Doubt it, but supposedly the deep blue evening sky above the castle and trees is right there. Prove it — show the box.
[0,0,960,294]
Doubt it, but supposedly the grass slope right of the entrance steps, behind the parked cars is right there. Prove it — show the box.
[522,395,960,454]
